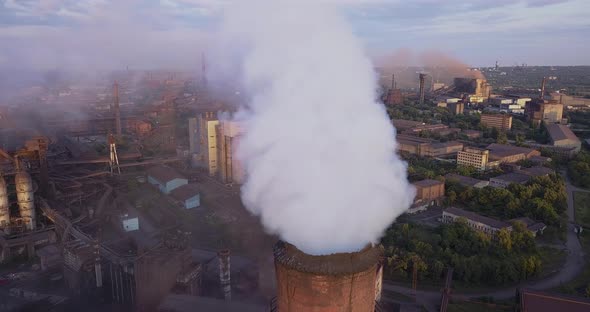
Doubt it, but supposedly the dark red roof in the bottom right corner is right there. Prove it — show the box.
[520,289,590,312]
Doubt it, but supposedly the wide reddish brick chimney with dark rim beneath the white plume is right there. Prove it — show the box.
[274,241,383,312]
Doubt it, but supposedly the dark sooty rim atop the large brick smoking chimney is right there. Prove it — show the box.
[274,241,383,275]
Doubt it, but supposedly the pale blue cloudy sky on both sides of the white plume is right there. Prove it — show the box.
[0,0,590,68]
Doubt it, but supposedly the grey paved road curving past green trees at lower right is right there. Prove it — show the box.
[383,175,586,311]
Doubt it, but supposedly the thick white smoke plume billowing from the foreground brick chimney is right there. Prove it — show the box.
[220,0,415,254]
